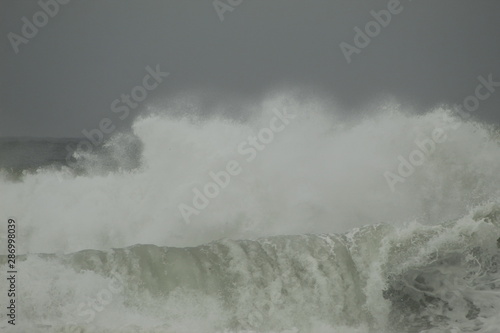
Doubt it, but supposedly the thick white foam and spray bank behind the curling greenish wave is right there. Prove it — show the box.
[0,94,500,253]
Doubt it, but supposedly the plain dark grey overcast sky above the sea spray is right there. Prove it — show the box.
[0,0,500,137]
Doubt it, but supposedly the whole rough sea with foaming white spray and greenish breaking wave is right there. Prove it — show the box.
[0,96,500,333]
